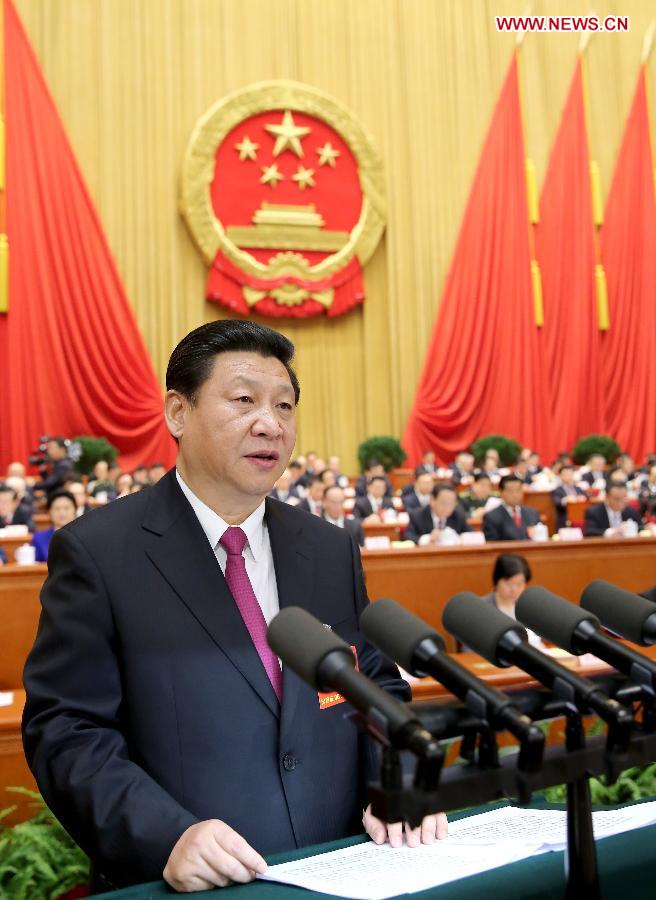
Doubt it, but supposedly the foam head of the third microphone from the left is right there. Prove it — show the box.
[442,591,528,666]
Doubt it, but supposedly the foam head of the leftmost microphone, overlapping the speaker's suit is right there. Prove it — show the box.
[267,606,355,691]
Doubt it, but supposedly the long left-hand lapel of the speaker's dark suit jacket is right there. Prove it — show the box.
[143,470,280,716]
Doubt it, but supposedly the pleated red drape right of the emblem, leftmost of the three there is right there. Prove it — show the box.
[403,58,547,464]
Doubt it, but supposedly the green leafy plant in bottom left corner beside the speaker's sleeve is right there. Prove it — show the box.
[0,787,89,900]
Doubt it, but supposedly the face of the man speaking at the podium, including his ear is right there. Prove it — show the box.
[167,352,296,502]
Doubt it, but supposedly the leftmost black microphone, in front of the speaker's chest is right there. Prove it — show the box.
[267,606,435,756]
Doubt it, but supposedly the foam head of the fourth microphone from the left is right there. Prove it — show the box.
[515,585,599,654]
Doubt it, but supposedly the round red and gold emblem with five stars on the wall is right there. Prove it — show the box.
[181,81,385,318]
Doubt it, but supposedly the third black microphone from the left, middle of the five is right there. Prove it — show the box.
[442,592,633,749]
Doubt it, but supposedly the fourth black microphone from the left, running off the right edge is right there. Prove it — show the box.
[515,585,656,695]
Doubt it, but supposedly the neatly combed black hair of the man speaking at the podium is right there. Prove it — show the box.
[166,319,301,404]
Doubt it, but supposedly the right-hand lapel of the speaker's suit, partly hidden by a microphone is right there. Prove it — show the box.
[265,498,314,730]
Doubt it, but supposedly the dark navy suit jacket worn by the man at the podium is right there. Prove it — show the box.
[23,471,410,885]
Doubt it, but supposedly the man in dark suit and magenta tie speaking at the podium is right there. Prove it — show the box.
[23,320,444,891]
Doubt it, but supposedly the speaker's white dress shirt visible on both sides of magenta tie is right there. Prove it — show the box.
[175,469,280,625]
